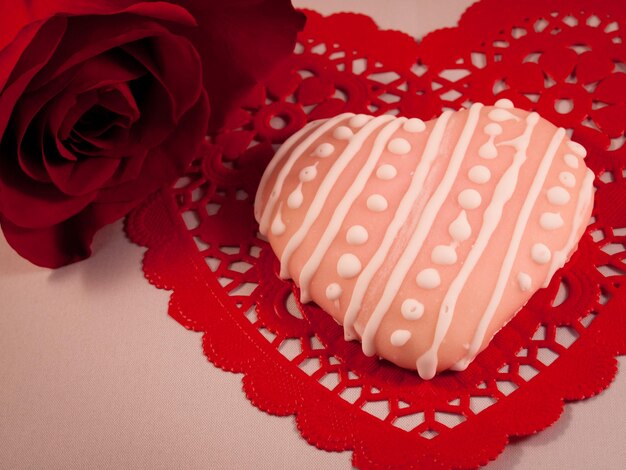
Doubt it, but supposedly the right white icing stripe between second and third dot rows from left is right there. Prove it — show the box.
[361,103,483,356]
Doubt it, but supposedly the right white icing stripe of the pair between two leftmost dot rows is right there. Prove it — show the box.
[298,118,406,302]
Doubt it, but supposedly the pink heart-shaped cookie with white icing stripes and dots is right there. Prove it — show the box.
[255,100,593,379]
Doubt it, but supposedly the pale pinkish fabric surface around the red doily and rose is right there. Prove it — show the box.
[0,0,626,469]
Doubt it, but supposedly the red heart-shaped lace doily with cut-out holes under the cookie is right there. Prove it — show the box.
[127,0,626,468]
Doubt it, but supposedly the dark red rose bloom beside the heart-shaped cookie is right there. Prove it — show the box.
[0,0,302,267]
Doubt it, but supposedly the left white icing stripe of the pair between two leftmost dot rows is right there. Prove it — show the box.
[280,115,395,279]
